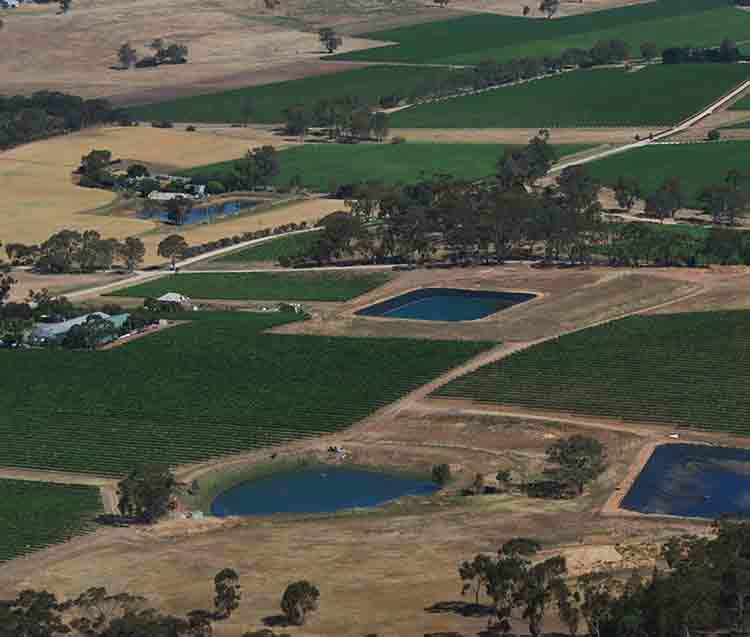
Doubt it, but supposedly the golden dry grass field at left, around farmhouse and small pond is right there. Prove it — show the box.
[0,126,312,263]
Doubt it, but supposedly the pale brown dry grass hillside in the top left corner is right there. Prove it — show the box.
[0,0,412,96]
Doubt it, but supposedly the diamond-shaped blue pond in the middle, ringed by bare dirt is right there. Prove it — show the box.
[356,288,534,321]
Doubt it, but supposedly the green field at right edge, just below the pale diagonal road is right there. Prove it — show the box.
[586,141,750,205]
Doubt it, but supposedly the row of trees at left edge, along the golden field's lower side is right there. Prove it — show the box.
[5,230,146,274]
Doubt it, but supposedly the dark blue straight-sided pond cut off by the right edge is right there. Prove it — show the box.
[621,444,750,519]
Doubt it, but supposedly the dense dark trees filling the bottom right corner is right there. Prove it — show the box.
[458,520,750,637]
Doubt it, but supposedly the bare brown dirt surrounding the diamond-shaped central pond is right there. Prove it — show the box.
[279,265,702,342]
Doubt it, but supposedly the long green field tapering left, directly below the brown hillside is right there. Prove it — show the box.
[127,66,458,124]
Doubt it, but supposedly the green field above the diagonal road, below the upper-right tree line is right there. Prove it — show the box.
[390,64,750,128]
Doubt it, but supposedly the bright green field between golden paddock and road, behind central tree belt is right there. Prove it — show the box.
[183,142,591,192]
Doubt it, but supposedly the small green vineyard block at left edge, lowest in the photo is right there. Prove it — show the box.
[0,479,102,563]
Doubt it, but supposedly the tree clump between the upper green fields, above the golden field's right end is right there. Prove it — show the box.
[284,97,388,141]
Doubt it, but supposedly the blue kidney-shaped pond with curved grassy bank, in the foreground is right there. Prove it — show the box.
[211,467,437,517]
